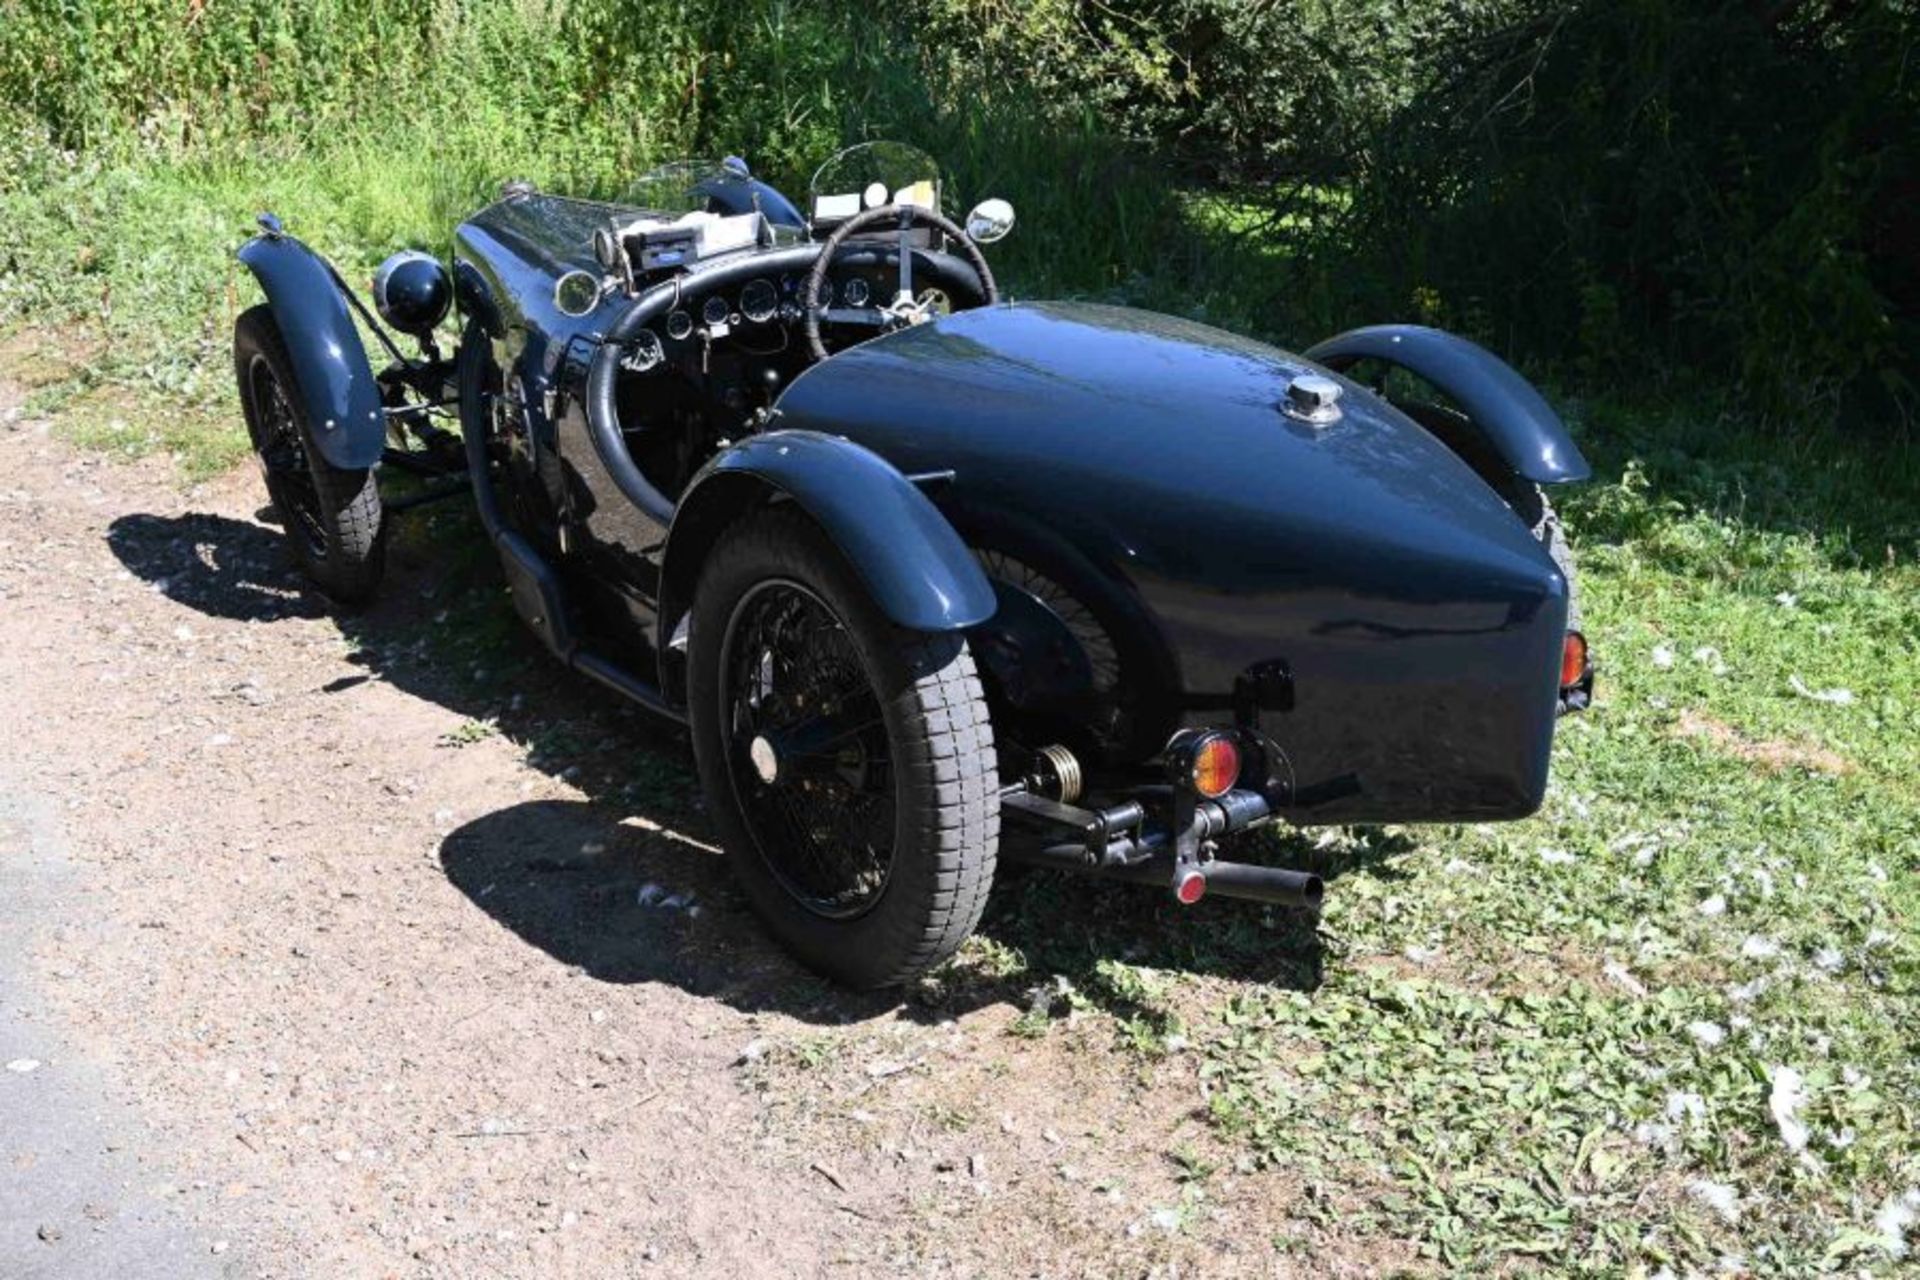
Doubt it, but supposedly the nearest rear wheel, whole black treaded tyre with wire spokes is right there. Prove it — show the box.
[687,510,1000,986]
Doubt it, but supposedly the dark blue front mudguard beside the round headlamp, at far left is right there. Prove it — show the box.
[240,232,386,470]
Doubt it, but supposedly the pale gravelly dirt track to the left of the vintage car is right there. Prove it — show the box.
[0,378,1363,1276]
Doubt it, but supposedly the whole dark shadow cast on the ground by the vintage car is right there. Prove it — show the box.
[108,509,1367,1025]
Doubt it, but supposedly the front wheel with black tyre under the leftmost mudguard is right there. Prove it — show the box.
[234,305,386,604]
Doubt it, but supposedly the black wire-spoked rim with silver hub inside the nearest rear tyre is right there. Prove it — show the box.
[722,580,899,919]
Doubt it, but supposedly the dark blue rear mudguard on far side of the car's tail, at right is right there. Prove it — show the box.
[1306,324,1594,484]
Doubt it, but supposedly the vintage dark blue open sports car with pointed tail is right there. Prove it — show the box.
[234,142,1592,986]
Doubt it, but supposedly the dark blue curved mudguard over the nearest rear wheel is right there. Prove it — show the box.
[660,432,996,649]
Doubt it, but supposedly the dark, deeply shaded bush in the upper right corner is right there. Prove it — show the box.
[1311,0,1920,422]
